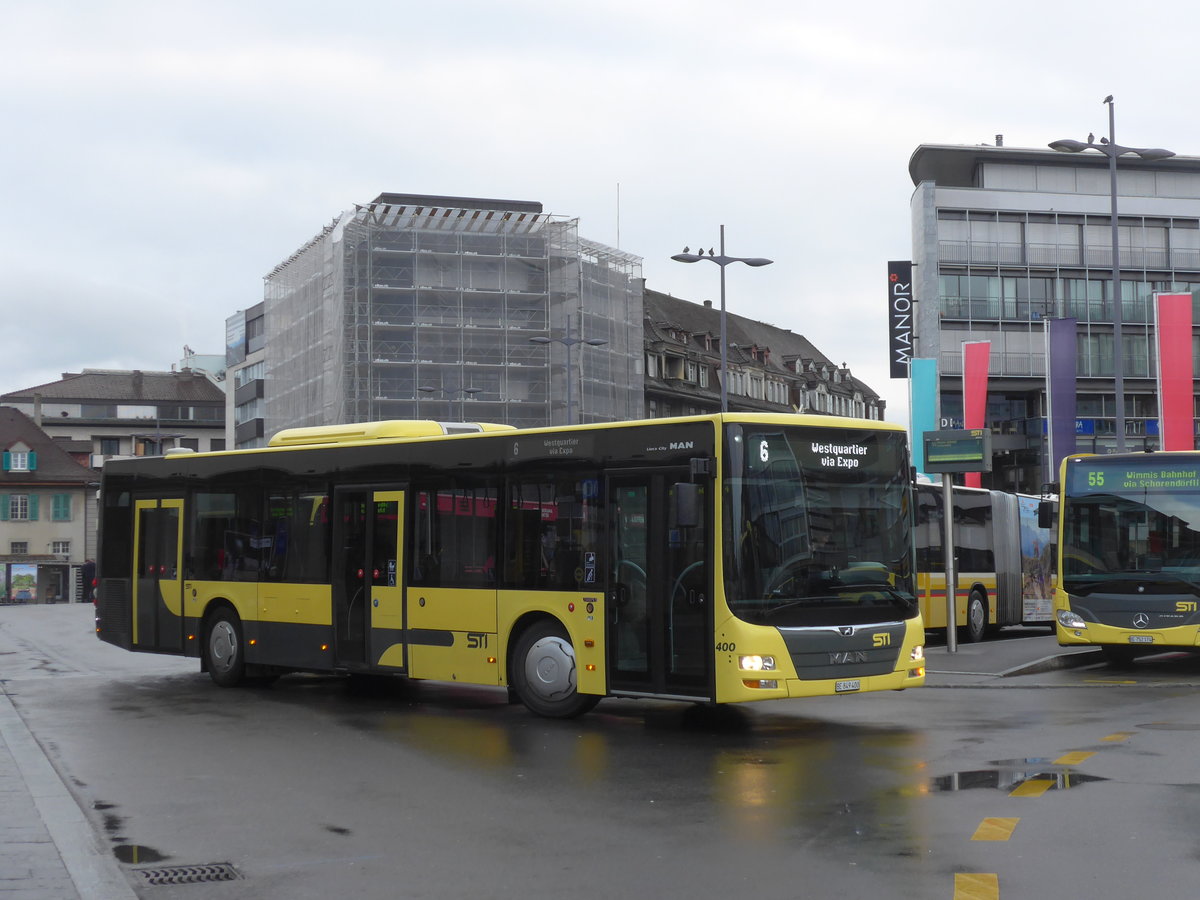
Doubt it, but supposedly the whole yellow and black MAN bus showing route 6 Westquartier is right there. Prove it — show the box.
[97,415,925,718]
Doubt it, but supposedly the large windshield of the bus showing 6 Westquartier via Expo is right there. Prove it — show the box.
[725,425,916,626]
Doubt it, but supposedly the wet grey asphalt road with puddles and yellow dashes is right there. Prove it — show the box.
[0,606,1200,900]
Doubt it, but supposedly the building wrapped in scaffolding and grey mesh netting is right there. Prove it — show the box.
[252,193,642,446]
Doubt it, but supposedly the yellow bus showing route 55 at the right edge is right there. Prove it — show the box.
[1055,451,1200,666]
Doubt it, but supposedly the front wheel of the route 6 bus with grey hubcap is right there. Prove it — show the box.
[512,622,600,719]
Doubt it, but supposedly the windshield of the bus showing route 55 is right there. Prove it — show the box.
[1062,455,1200,594]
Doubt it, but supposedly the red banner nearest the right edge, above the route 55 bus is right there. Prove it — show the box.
[1154,294,1195,450]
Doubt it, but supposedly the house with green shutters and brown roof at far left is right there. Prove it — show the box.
[0,407,98,602]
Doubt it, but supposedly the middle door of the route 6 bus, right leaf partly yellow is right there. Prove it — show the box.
[332,487,406,671]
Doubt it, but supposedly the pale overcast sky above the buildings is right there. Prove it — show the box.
[0,0,1200,421]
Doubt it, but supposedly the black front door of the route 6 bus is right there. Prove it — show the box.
[606,472,713,698]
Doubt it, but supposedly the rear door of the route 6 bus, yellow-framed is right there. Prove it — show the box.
[133,499,184,650]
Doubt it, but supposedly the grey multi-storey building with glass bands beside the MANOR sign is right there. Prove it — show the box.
[908,144,1200,492]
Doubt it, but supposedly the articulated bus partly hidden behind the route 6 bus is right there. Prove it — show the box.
[916,484,1055,642]
